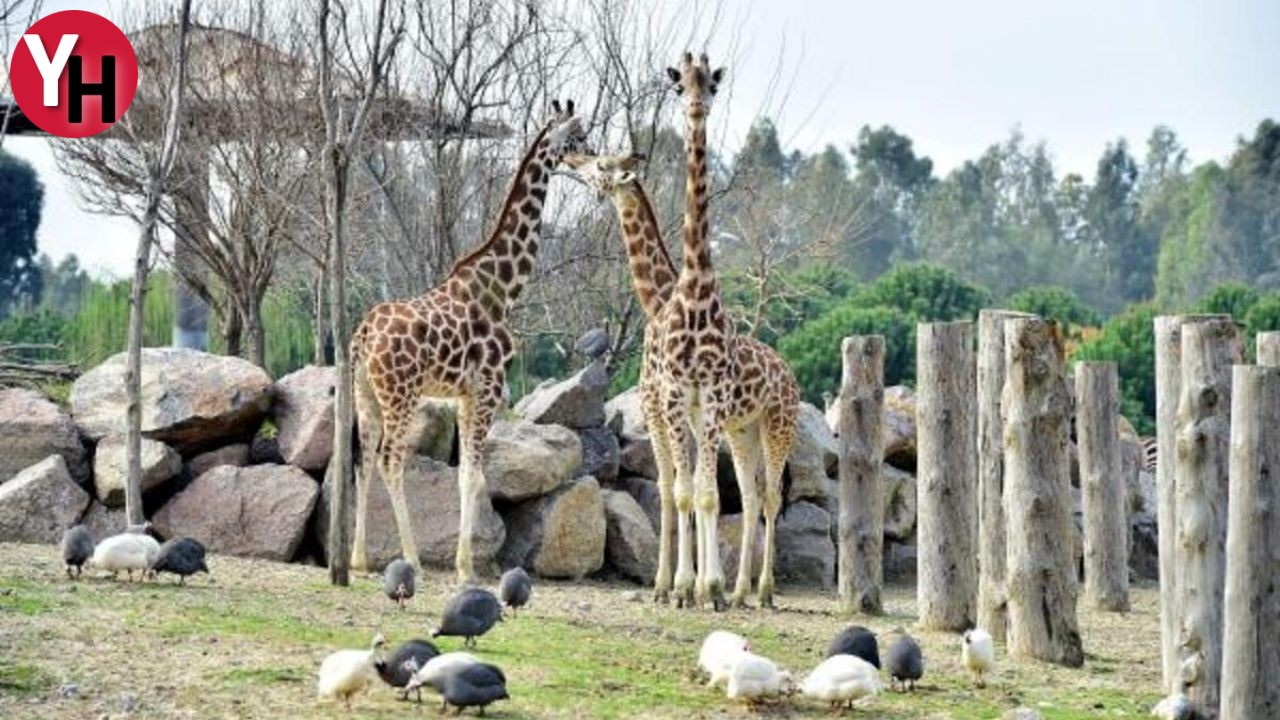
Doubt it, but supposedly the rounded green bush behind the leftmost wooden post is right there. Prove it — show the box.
[778,302,915,407]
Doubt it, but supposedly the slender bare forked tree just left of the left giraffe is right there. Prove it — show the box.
[316,0,404,585]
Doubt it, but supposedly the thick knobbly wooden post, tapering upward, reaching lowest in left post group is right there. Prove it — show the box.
[1001,318,1084,667]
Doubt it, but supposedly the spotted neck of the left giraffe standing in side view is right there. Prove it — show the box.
[445,129,563,318]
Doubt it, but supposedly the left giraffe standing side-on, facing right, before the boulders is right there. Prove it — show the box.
[351,102,586,583]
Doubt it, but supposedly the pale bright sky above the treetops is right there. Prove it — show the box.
[5,0,1280,277]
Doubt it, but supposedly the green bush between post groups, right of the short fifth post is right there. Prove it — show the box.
[1071,304,1158,436]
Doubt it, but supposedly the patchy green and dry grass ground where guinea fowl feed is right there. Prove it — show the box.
[0,544,1160,720]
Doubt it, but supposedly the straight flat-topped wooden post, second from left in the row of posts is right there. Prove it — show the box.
[915,323,978,630]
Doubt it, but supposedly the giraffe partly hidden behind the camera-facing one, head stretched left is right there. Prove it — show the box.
[564,155,800,607]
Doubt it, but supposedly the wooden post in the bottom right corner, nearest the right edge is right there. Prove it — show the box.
[1221,363,1280,719]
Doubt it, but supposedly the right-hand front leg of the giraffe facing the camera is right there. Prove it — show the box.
[694,398,726,611]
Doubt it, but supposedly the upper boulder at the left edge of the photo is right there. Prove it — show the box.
[0,387,88,483]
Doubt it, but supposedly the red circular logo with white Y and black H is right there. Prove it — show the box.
[9,10,138,137]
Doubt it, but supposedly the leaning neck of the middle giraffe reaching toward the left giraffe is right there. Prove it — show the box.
[613,181,677,318]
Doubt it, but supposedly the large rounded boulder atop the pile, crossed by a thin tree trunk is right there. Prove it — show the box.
[72,347,271,454]
